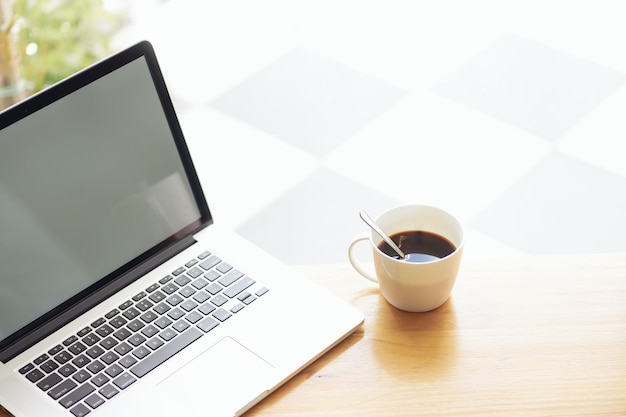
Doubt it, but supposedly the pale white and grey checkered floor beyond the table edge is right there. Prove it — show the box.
[120,0,626,264]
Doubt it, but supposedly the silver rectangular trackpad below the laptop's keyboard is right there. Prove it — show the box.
[159,337,274,416]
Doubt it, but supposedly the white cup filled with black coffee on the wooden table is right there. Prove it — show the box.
[348,205,464,312]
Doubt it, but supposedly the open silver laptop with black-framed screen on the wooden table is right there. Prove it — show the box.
[0,41,363,417]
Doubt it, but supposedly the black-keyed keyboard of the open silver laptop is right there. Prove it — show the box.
[19,252,268,416]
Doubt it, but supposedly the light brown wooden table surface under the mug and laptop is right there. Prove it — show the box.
[0,254,626,417]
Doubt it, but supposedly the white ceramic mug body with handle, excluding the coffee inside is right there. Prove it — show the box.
[348,205,464,312]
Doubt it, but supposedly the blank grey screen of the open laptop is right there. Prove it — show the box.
[0,42,210,356]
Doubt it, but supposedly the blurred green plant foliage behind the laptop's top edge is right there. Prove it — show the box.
[0,0,123,109]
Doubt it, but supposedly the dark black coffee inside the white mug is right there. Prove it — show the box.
[378,230,456,262]
